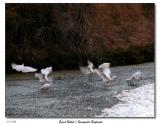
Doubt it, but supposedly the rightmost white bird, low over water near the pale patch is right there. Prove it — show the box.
[126,71,142,85]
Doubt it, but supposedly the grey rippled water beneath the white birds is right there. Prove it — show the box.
[5,63,155,118]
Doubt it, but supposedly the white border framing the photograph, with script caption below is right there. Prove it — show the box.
[0,0,160,124]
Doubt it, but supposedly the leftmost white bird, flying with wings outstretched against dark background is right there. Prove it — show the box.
[11,63,37,73]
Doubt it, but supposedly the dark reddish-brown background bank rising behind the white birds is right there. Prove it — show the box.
[6,4,154,69]
